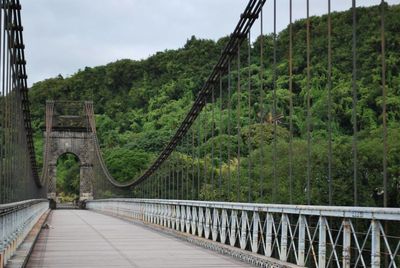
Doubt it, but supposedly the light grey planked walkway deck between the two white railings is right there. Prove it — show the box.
[27,210,249,267]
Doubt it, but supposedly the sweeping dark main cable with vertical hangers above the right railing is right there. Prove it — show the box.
[125,0,398,207]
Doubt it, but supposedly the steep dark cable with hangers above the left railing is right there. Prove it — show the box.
[0,0,44,203]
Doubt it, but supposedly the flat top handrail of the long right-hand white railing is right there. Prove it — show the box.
[88,198,400,221]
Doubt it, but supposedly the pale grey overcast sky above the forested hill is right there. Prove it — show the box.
[21,0,400,85]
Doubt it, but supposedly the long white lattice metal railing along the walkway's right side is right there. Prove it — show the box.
[86,199,400,267]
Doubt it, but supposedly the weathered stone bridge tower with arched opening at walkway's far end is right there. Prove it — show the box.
[42,101,96,201]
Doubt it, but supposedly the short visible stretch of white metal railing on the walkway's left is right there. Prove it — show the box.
[0,199,49,267]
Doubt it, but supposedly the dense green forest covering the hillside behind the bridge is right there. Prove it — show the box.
[29,5,400,206]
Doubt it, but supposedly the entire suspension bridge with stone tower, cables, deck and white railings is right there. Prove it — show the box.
[0,0,400,268]
